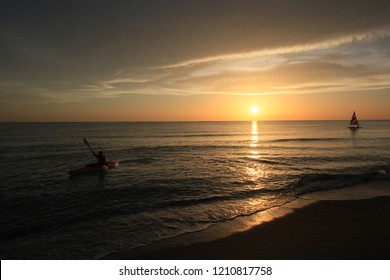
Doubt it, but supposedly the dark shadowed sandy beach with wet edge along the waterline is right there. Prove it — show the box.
[107,180,390,260]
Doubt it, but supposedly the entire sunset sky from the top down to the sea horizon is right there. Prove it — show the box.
[0,0,390,122]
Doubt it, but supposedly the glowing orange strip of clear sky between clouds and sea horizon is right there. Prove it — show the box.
[0,88,389,121]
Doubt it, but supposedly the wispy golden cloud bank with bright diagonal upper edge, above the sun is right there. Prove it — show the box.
[90,29,390,98]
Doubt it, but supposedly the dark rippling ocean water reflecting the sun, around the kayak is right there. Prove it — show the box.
[0,121,390,259]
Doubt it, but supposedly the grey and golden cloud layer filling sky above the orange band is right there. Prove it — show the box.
[0,0,390,105]
